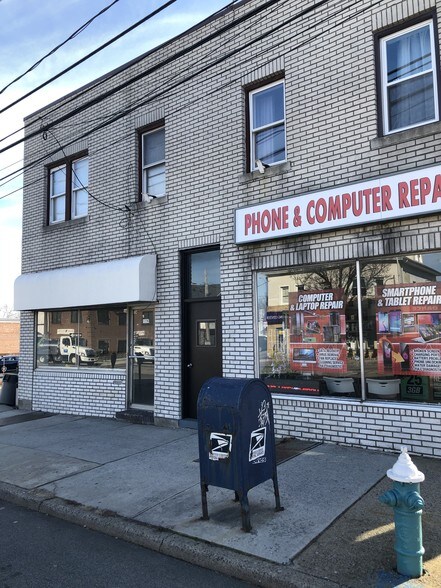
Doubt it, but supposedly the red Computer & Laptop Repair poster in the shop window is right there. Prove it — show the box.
[289,288,347,374]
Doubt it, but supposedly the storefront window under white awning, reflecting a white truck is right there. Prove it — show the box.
[35,307,127,368]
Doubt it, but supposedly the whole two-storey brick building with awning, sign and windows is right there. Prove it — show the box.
[16,0,441,456]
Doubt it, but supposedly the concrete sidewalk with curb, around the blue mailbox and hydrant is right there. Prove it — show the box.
[0,405,441,588]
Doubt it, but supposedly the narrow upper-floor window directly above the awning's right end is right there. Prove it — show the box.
[142,127,165,199]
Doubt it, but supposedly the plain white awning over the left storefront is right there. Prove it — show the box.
[14,254,156,310]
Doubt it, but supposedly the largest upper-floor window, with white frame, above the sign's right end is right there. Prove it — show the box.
[380,20,438,135]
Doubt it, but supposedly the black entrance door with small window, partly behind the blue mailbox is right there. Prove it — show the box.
[183,300,222,419]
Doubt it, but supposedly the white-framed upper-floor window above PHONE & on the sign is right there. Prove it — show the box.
[249,80,286,171]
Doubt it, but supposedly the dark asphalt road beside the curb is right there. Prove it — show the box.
[0,501,251,588]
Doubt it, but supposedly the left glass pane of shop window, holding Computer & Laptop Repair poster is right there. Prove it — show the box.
[257,263,360,396]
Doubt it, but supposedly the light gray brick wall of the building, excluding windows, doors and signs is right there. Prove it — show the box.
[18,0,441,457]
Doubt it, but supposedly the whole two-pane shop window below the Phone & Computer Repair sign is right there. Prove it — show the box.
[257,256,441,402]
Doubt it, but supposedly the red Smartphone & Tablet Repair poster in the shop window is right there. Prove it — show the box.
[376,282,441,376]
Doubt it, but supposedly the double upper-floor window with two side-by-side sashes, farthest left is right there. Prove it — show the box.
[49,156,89,224]
